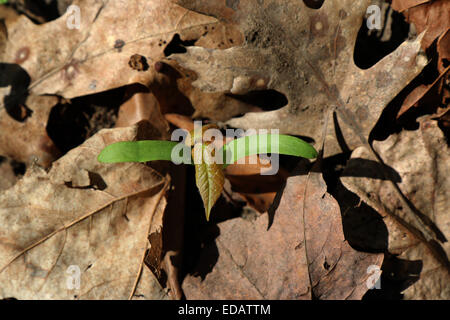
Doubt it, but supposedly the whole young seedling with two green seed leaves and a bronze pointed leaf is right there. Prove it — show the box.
[98,126,317,220]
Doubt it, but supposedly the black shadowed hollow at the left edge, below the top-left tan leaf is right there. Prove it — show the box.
[0,63,32,122]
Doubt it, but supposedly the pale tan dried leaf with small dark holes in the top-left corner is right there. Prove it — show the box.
[1,0,210,98]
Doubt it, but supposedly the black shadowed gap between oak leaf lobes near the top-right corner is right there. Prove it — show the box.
[353,5,409,69]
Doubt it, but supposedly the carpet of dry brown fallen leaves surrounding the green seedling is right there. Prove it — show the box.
[0,0,449,299]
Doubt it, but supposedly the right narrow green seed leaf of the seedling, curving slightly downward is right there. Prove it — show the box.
[222,134,317,167]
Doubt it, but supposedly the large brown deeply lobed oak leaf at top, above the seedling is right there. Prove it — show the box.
[171,0,427,155]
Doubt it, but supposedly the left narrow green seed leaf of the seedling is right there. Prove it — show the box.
[98,140,178,163]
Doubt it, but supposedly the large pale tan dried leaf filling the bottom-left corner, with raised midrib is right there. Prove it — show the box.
[0,123,168,299]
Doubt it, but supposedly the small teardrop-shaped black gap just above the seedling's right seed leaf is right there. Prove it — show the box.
[227,89,288,111]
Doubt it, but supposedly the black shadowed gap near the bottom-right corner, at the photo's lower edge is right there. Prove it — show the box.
[362,253,423,300]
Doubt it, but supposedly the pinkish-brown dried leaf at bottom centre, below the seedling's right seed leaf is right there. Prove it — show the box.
[182,164,383,299]
